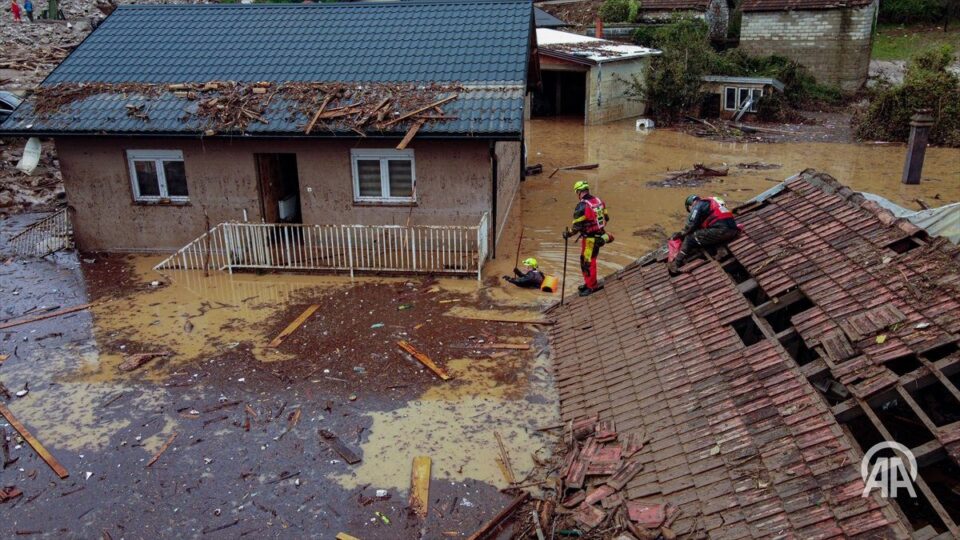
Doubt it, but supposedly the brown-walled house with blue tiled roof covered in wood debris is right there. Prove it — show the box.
[0,0,538,271]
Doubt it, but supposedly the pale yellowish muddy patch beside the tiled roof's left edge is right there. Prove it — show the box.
[332,355,559,493]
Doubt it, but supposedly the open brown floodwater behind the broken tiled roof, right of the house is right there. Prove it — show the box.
[512,119,960,295]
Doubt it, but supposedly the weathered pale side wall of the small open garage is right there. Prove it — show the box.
[585,56,650,125]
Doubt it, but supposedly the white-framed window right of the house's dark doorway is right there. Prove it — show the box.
[350,148,417,203]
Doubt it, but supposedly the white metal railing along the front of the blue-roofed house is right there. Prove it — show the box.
[154,214,488,279]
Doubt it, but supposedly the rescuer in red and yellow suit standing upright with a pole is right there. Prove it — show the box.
[563,184,613,296]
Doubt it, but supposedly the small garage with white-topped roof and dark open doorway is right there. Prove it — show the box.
[531,28,660,125]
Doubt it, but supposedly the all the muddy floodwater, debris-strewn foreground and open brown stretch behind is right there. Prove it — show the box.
[0,120,960,539]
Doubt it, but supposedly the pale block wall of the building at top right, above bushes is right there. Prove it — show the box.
[740,0,877,91]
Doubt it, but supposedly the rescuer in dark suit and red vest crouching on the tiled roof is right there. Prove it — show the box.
[667,195,740,274]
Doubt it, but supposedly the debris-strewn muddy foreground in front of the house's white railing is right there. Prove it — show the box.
[0,216,556,539]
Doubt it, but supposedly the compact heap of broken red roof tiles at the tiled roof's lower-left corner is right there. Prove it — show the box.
[549,418,679,540]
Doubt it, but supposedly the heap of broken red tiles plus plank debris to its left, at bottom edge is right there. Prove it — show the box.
[480,417,692,540]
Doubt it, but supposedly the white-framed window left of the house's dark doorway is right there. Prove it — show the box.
[127,150,190,203]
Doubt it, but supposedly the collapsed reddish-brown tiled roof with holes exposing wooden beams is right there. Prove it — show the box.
[551,170,960,538]
